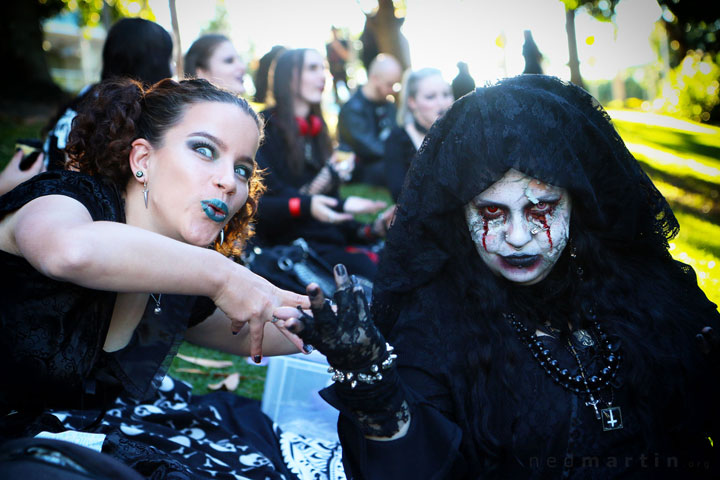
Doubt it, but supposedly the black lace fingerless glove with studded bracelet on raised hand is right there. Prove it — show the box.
[300,281,410,437]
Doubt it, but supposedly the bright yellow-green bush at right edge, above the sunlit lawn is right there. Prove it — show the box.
[655,50,720,122]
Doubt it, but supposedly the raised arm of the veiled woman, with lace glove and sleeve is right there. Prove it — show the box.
[278,266,467,479]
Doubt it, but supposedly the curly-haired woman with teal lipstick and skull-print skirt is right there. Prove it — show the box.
[0,79,344,479]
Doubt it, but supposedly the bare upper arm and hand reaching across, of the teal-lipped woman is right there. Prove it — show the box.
[0,195,309,355]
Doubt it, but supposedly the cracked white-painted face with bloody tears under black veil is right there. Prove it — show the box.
[465,169,571,285]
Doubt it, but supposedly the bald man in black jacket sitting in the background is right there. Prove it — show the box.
[338,53,402,186]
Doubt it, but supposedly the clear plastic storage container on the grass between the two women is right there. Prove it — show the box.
[262,351,338,441]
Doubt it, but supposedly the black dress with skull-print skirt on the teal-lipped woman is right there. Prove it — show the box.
[0,171,343,479]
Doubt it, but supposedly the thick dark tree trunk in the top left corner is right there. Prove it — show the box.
[0,1,64,106]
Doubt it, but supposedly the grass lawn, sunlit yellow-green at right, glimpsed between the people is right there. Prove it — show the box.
[0,111,720,399]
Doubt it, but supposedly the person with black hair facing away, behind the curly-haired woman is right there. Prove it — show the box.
[43,18,173,170]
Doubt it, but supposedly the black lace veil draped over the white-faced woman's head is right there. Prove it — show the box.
[377,75,679,300]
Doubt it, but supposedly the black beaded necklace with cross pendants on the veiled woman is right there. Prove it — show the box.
[507,314,623,431]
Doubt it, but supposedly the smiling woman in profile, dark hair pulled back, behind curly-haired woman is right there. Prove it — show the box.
[185,33,247,95]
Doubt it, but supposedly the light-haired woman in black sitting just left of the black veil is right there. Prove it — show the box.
[383,68,453,202]
